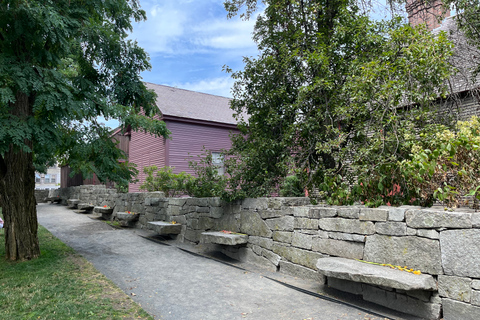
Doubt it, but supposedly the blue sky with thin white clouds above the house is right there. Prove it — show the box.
[101,0,402,128]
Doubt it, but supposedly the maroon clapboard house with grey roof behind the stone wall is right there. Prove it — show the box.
[115,83,238,192]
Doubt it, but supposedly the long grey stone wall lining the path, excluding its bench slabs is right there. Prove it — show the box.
[47,186,480,320]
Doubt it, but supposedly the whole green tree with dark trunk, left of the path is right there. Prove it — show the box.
[0,0,168,260]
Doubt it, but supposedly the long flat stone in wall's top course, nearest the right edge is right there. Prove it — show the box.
[405,210,472,229]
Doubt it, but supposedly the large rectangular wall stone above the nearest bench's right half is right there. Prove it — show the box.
[364,235,443,274]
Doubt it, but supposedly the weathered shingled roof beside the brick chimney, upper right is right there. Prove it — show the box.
[433,16,480,93]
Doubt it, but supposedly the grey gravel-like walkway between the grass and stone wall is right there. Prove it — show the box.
[37,204,416,320]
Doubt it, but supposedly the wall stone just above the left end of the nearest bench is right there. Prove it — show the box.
[312,238,364,259]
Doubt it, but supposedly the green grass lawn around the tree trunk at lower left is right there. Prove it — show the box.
[0,212,153,320]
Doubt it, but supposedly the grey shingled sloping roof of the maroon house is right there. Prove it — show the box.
[145,82,237,125]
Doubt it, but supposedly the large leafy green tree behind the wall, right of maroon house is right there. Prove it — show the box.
[226,0,452,203]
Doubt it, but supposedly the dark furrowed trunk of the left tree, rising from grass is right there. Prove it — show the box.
[0,93,40,260]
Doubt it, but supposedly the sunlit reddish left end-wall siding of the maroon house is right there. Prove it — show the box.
[128,131,166,192]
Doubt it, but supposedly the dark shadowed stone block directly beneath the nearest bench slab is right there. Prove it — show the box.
[363,286,442,320]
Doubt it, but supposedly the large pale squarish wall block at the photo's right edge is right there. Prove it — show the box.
[440,229,480,278]
